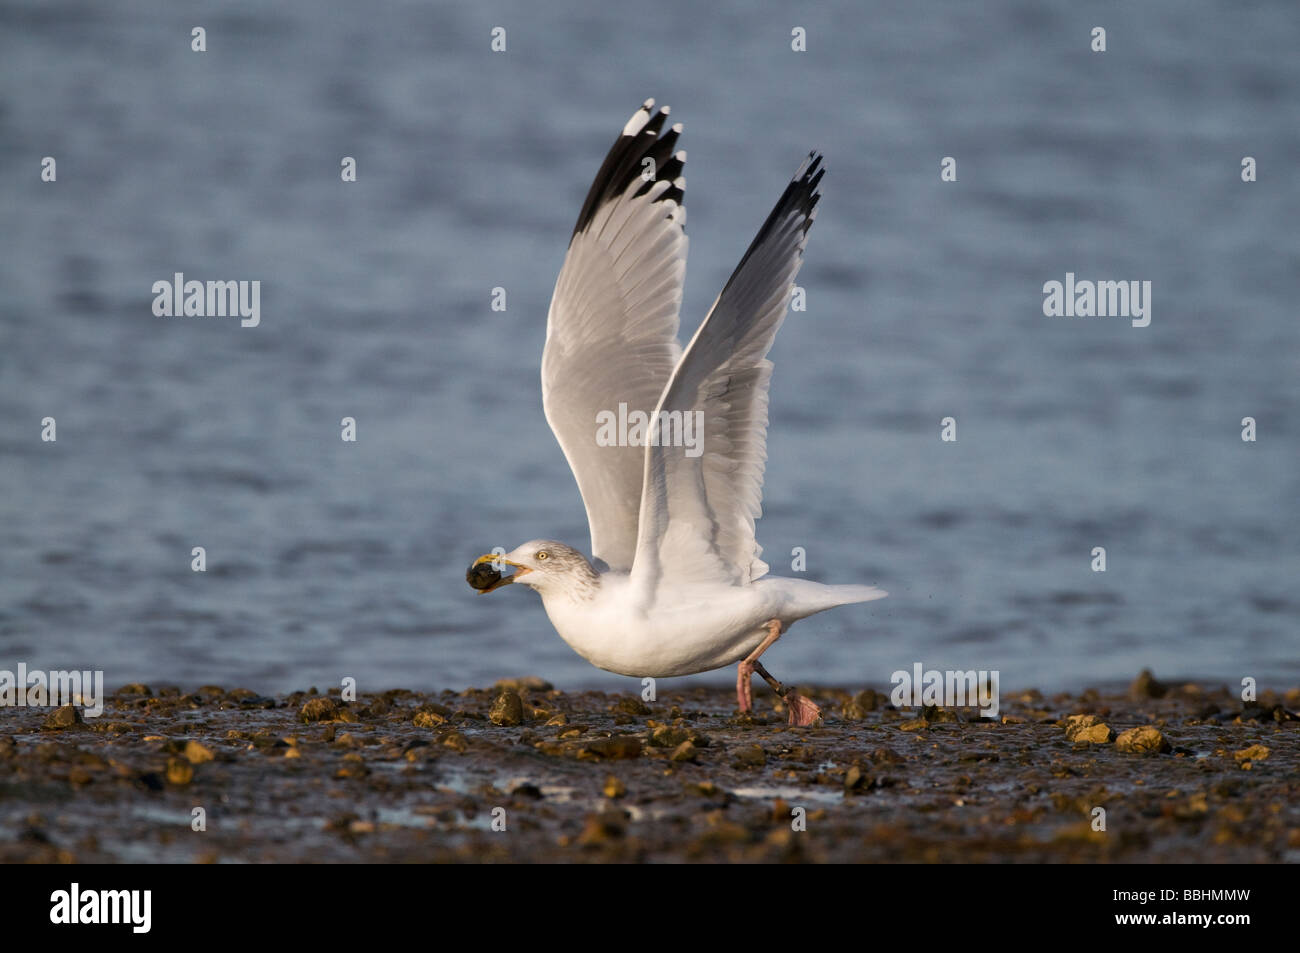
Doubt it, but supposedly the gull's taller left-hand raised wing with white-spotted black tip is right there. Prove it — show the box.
[542,100,686,569]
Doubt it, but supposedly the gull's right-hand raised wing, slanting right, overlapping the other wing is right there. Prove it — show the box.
[632,152,824,602]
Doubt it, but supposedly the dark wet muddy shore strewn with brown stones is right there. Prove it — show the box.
[0,677,1300,863]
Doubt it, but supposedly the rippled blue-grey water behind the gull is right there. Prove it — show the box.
[0,0,1300,692]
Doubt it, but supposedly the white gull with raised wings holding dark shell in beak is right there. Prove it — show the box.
[467,99,887,725]
